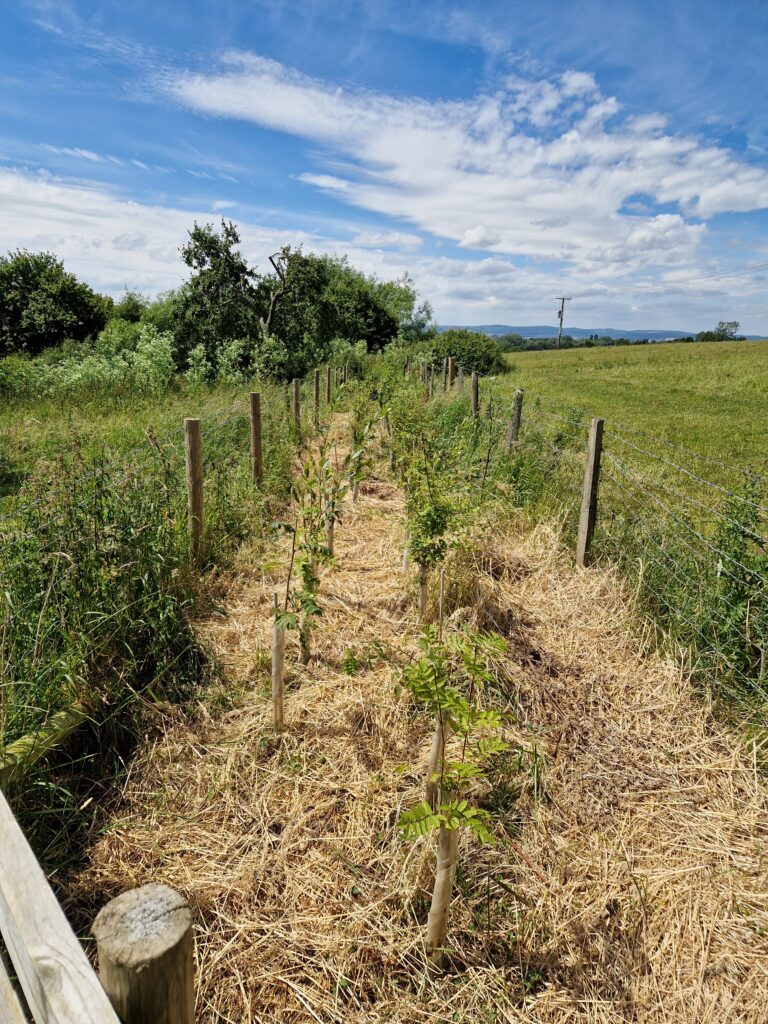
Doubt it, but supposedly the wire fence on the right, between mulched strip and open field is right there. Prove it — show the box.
[405,370,768,724]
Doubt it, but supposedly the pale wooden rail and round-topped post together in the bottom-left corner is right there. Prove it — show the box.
[0,793,195,1024]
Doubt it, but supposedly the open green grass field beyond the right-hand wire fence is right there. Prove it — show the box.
[504,341,768,472]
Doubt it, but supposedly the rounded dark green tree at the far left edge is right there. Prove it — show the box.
[0,249,113,355]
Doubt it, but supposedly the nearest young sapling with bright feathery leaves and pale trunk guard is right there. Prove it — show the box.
[399,627,509,968]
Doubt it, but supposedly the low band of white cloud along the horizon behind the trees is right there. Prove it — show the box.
[0,167,768,332]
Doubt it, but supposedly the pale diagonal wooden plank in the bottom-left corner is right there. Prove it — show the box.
[0,793,119,1024]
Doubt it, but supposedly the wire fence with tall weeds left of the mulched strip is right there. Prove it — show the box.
[0,376,311,753]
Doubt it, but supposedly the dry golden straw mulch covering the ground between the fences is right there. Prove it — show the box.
[76,466,768,1024]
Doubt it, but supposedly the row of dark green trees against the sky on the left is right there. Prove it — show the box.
[0,220,434,380]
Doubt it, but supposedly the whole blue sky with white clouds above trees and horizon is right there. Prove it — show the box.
[0,0,768,333]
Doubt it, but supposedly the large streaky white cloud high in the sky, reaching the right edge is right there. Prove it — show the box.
[162,52,768,272]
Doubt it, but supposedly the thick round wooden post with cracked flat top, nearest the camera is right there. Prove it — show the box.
[93,884,195,1024]
